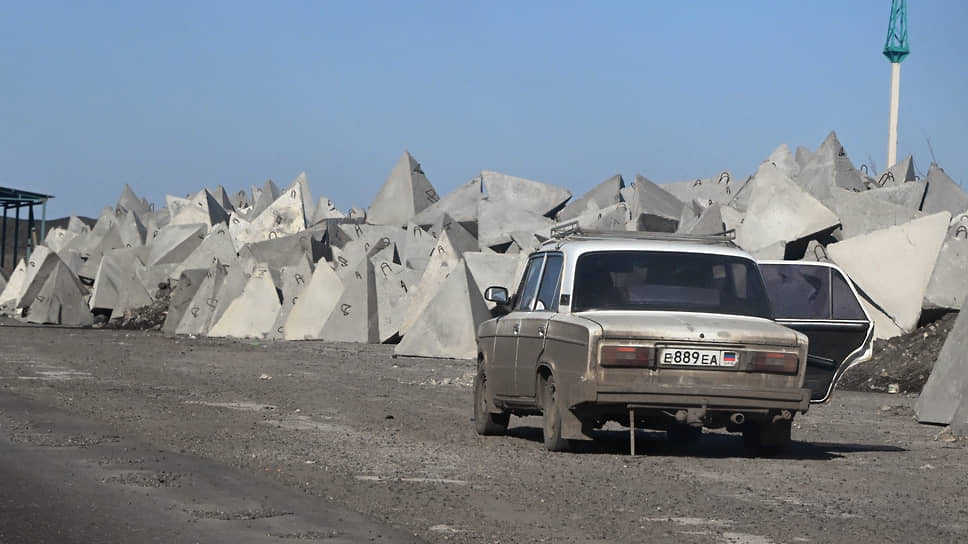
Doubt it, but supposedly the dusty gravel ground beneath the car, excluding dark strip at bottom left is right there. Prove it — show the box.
[0,321,968,544]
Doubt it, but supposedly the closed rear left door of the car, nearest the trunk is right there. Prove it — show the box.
[514,252,564,397]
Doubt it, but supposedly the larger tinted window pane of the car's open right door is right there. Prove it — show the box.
[760,264,831,319]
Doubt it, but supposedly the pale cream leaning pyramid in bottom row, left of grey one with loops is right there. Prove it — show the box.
[284,260,343,340]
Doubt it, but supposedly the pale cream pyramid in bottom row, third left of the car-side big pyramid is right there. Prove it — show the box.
[208,265,281,338]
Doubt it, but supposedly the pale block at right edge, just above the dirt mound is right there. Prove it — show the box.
[924,211,968,310]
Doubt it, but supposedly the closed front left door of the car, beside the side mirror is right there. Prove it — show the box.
[487,253,544,396]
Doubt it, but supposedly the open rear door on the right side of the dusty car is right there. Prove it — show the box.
[759,261,874,403]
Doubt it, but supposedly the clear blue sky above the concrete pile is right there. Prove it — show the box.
[0,0,968,217]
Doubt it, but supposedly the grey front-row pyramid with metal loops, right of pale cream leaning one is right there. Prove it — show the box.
[319,259,380,343]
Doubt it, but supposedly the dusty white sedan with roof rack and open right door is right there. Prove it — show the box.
[474,227,873,453]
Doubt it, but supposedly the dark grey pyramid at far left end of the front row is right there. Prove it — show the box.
[27,257,94,327]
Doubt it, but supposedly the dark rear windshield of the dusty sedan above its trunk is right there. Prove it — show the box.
[572,251,771,318]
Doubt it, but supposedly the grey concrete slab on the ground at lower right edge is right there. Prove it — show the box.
[914,299,968,425]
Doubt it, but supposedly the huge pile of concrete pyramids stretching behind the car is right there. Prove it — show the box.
[0,133,968,380]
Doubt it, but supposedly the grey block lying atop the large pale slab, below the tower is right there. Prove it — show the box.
[824,187,925,239]
